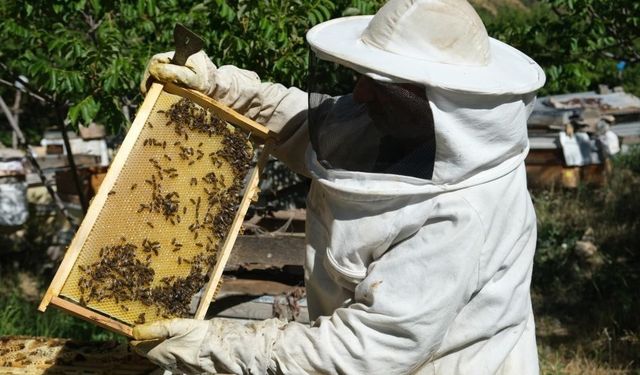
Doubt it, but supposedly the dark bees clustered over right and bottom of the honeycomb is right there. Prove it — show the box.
[78,99,254,324]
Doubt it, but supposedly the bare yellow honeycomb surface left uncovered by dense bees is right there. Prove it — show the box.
[60,92,252,324]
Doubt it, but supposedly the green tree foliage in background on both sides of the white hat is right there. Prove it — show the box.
[0,0,640,134]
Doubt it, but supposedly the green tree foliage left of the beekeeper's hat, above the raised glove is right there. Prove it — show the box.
[0,0,380,139]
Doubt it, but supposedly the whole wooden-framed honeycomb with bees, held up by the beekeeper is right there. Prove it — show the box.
[40,84,270,336]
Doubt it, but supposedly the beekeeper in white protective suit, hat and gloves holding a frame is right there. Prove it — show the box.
[133,0,545,375]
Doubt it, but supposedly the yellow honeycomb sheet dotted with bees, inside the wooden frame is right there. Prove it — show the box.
[60,92,254,325]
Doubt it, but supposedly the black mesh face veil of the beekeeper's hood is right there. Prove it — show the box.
[309,56,436,179]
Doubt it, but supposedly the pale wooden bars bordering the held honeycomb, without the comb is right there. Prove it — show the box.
[38,83,274,337]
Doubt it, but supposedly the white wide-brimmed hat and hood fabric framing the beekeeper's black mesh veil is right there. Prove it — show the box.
[307,0,545,194]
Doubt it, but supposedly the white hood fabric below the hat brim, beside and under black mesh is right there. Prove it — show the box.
[307,88,535,197]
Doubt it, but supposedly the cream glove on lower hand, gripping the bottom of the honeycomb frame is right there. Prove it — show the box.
[131,318,284,374]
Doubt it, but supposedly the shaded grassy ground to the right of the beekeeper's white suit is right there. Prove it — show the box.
[532,147,640,374]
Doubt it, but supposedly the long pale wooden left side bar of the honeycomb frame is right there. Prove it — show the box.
[38,83,162,311]
